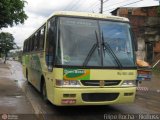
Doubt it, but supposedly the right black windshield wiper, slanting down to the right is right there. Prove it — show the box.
[102,32,123,68]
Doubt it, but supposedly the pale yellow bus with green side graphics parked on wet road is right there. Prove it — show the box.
[22,11,137,106]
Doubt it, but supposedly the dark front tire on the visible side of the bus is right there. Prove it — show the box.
[41,77,48,103]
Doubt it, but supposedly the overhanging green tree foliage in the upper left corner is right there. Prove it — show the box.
[0,0,27,29]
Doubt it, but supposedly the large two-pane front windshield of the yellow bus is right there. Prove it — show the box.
[56,17,135,67]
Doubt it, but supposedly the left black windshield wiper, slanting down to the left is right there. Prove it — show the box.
[83,31,100,66]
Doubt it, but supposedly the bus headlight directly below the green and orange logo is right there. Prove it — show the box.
[56,80,81,87]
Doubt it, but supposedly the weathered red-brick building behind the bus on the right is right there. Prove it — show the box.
[112,6,160,63]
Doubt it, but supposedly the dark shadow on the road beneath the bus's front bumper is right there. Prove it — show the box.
[45,103,120,120]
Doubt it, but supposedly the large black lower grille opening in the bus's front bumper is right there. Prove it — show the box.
[82,93,119,102]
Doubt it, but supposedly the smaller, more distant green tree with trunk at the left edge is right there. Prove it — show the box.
[0,32,18,63]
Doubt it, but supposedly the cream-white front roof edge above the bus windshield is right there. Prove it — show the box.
[49,11,129,22]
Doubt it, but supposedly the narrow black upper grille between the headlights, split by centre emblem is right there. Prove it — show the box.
[81,80,121,86]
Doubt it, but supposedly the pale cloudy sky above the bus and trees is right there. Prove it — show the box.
[0,0,159,48]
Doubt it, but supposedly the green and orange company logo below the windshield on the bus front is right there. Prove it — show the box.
[63,69,90,80]
